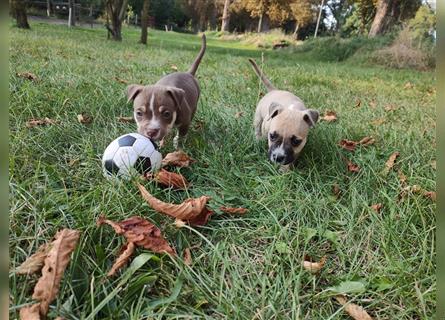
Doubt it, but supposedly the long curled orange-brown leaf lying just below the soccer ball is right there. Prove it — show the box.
[138,184,213,225]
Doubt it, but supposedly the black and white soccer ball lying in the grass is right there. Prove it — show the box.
[102,133,162,178]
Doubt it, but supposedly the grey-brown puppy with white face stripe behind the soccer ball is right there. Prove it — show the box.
[127,35,206,148]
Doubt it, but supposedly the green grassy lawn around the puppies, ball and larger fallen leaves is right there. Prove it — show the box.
[9,24,436,319]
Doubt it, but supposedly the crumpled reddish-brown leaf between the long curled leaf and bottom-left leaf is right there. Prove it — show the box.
[96,216,176,255]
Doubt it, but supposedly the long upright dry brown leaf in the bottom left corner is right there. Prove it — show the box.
[32,229,80,316]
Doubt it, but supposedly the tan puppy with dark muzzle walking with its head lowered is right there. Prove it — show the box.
[249,59,319,166]
